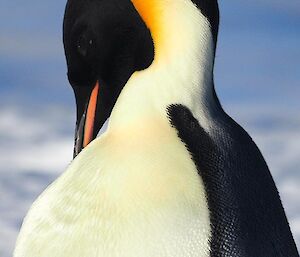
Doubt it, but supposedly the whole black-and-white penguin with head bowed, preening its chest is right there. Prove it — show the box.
[14,0,299,257]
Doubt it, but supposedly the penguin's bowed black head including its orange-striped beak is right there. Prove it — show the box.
[64,0,154,157]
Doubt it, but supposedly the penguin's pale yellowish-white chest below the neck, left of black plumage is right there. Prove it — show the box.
[15,129,210,257]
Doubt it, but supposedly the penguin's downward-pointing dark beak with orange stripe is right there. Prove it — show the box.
[74,80,101,158]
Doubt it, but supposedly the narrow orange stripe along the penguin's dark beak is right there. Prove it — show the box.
[83,81,99,147]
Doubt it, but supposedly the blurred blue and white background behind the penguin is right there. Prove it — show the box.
[0,0,300,257]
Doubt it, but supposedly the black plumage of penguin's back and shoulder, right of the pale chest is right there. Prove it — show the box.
[168,105,299,257]
